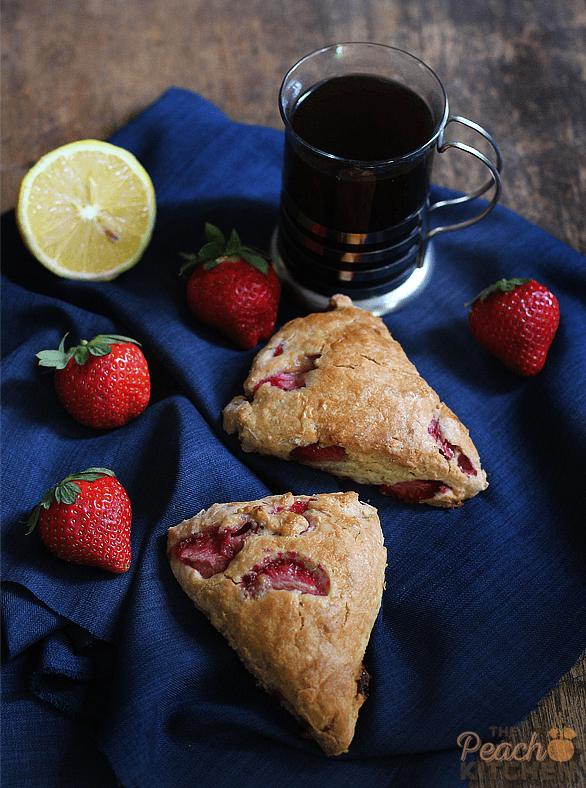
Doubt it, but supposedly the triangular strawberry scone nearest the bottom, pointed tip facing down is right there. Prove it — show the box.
[167,492,386,755]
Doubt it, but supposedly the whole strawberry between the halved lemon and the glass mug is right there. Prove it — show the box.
[181,223,281,350]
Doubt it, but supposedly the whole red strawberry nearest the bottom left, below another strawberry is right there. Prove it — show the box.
[28,468,132,574]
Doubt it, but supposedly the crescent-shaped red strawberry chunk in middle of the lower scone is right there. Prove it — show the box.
[242,553,330,599]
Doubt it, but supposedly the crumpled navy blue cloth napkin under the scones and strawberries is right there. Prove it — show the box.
[2,89,586,788]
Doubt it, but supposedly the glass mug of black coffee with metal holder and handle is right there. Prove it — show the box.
[272,43,502,315]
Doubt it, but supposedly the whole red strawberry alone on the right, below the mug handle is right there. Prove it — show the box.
[468,279,560,377]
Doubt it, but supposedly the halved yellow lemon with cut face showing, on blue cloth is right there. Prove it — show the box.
[16,140,156,280]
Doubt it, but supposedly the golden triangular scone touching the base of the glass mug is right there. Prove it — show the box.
[224,296,488,507]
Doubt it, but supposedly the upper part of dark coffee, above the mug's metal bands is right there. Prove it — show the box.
[284,74,433,233]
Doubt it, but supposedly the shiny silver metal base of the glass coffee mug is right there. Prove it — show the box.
[271,227,434,317]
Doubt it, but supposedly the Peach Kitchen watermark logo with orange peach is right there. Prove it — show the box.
[457,725,586,784]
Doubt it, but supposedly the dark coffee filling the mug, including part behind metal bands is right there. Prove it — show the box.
[279,74,434,295]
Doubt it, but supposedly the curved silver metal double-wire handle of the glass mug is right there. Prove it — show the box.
[426,115,503,240]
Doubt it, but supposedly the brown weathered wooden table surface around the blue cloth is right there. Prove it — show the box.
[1,0,586,788]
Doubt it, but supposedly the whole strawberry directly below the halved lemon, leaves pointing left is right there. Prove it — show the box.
[37,334,151,429]
